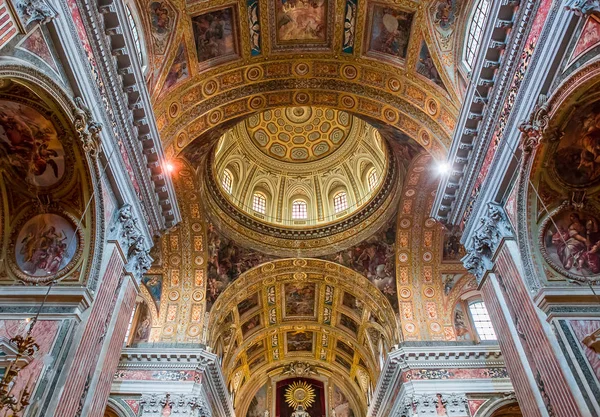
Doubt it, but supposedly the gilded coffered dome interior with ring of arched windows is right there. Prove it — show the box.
[212,106,389,228]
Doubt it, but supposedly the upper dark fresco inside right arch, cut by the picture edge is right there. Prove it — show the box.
[554,101,600,187]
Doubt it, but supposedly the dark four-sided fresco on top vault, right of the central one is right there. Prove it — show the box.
[369,4,413,60]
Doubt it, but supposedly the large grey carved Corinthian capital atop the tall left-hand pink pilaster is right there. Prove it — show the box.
[109,204,152,283]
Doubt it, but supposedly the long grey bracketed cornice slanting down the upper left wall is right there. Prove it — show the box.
[75,0,181,234]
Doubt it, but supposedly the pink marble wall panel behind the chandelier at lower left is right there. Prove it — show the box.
[0,320,60,393]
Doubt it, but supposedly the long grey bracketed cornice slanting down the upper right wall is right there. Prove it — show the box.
[432,0,538,224]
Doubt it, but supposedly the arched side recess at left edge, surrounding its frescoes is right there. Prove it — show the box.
[0,58,102,290]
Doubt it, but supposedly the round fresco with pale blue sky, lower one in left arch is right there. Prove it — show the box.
[15,213,79,277]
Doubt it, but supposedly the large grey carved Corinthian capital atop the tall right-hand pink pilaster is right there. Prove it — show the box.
[462,203,513,284]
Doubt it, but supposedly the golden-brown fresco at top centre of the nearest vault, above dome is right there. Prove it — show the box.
[272,0,328,43]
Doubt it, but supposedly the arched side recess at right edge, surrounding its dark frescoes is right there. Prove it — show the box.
[513,57,600,289]
